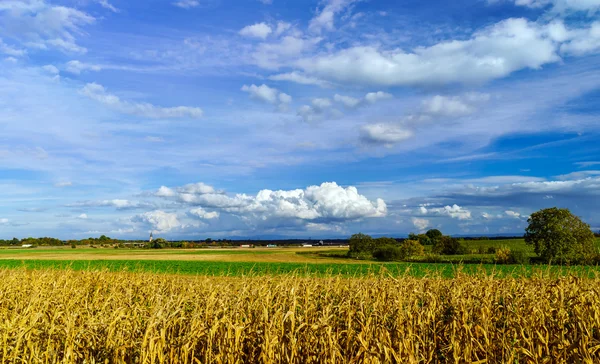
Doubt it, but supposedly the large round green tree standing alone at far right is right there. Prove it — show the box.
[525,207,594,262]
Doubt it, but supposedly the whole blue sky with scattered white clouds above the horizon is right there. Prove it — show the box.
[0,0,600,239]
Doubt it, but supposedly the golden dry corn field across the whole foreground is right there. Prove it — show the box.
[0,269,600,363]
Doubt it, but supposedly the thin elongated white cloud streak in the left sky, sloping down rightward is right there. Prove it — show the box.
[81,83,203,119]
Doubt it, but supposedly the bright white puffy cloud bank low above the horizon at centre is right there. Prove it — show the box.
[155,182,387,222]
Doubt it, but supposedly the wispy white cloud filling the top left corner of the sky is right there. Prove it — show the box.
[0,0,95,53]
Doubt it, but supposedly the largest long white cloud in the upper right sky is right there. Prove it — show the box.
[296,19,560,86]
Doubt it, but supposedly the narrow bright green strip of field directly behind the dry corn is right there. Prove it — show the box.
[0,259,600,278]
